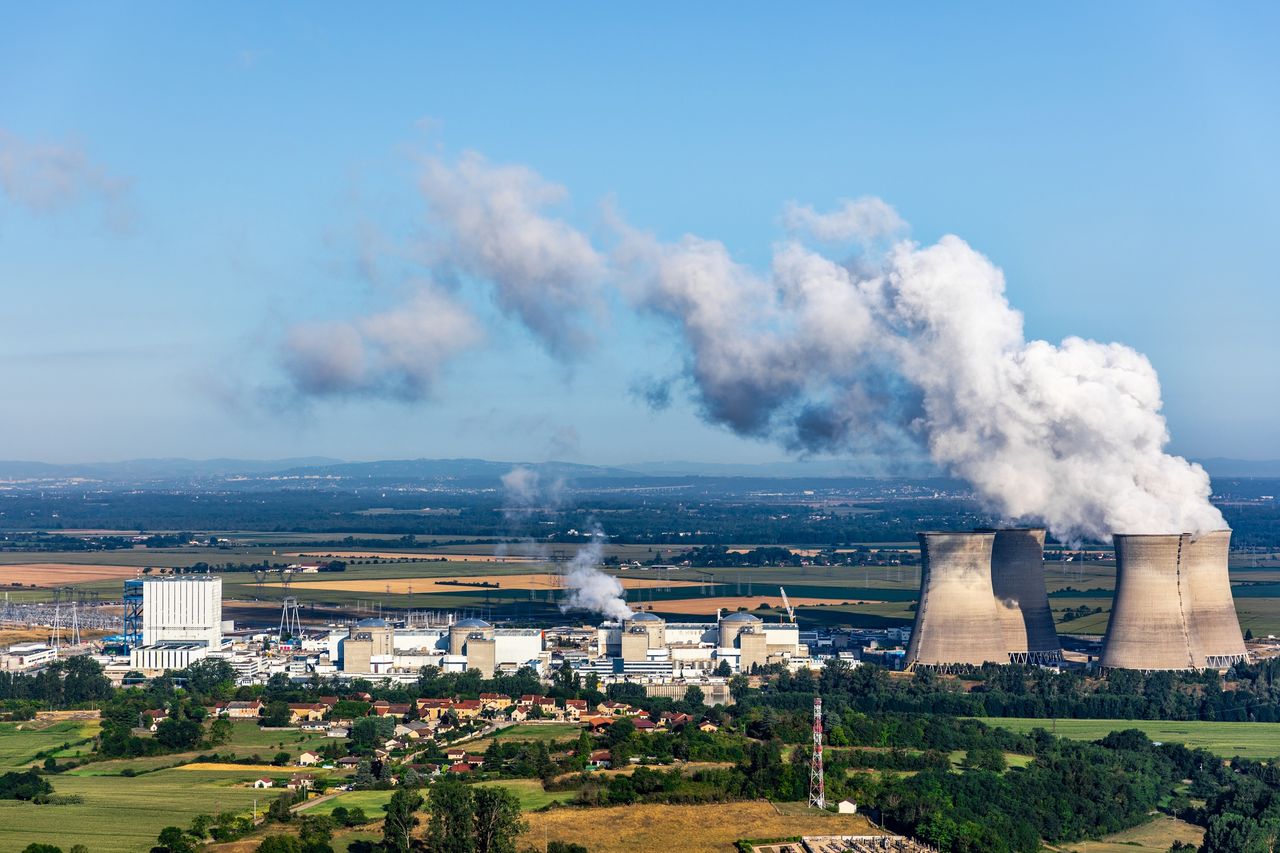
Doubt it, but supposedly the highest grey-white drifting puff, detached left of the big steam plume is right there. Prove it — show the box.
[419,152,605,360]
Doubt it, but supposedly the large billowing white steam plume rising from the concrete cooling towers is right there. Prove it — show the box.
[618,209,1225,539]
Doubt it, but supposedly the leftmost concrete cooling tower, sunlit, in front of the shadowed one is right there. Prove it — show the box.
[906,533,1009,669]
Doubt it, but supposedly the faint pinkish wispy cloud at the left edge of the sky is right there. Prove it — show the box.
[0,129,133,232]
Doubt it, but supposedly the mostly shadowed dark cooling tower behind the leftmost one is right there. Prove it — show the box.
[980,528,1062,663]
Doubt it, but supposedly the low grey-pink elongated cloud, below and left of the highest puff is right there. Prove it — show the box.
[282,286,484,401]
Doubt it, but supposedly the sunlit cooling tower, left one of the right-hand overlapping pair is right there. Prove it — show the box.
[1101,533,1197,670]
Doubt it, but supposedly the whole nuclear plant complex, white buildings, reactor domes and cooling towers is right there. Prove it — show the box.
[4,528,1247,681]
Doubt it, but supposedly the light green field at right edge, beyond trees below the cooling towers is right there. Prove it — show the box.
[982,717,1280,758]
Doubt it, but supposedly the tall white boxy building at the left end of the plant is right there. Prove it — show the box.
[142,575,223,648]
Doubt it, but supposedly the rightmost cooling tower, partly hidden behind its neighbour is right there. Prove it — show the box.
[1181,530,1248,670]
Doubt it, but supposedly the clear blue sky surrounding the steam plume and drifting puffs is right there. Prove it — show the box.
[0,3,1280,462]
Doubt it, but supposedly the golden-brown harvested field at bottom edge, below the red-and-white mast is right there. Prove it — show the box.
[521,800,877,853]
